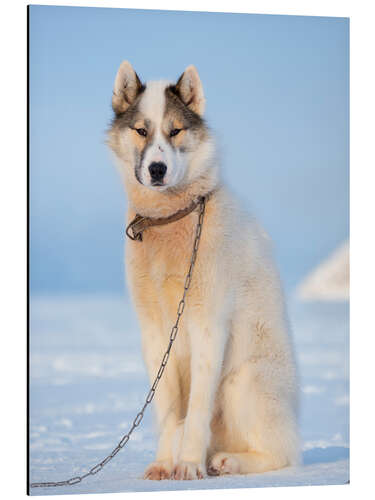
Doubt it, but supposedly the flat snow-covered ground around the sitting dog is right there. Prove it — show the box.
[30,296,349,495]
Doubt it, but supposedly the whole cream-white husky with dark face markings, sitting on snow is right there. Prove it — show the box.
[108,61,299,479]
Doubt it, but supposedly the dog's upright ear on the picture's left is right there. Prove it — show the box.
[112,61,144,115]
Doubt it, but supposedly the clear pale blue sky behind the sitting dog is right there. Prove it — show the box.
[29,6,349,294]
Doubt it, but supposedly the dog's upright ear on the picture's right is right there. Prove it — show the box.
[175,65,206,115]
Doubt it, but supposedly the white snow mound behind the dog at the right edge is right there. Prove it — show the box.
[297,241,350,301]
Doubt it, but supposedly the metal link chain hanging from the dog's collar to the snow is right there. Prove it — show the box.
[30,197,206,488]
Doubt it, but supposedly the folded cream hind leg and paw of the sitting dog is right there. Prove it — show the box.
[207,354,299,475]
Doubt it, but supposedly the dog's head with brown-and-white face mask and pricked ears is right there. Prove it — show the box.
[108,61,214,191]
